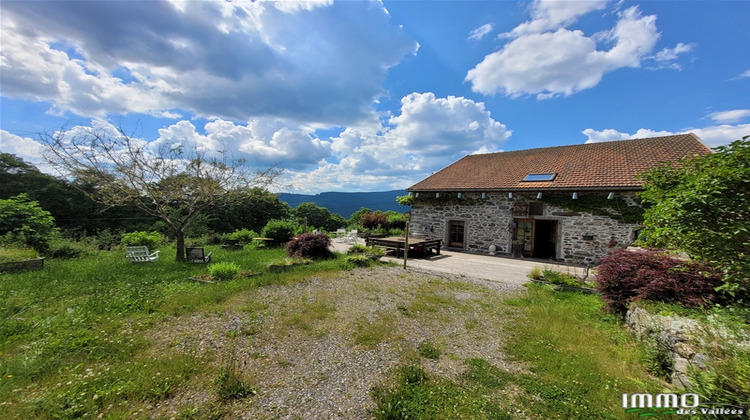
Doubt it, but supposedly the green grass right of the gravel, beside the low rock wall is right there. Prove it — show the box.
[372,286,665,419]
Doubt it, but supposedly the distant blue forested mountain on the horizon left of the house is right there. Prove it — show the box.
[279,190,409,219]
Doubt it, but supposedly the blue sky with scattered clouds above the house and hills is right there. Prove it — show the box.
[0,0,750,193]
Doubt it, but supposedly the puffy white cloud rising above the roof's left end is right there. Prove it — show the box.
[289,92,511,192]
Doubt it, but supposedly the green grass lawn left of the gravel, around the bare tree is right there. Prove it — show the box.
[0,246,356,418]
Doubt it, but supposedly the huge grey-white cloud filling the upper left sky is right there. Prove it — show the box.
[0,0,417,124]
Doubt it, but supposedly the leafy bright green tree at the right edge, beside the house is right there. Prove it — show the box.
[641,136,750,293]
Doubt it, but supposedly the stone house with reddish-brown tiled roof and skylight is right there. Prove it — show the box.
[407,134,711,264]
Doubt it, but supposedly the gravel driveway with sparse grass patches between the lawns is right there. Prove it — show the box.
[149,267,520,419]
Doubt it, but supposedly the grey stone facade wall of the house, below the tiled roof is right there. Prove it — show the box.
[411,193,639,264]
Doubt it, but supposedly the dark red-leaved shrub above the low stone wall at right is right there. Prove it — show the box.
[596,250,721,314]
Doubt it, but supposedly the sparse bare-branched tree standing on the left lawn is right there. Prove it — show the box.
[40,126,279,261]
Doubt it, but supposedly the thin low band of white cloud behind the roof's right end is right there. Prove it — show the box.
[583,124,750,147]
